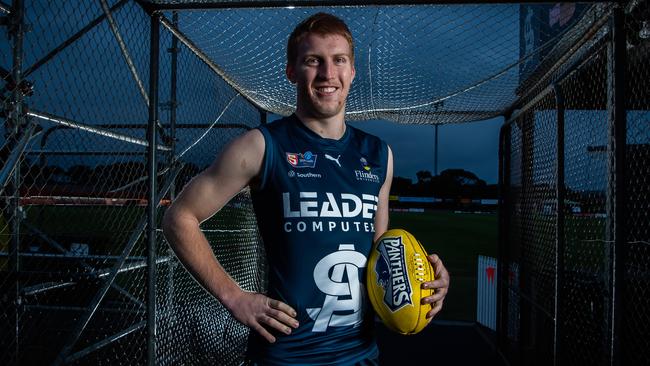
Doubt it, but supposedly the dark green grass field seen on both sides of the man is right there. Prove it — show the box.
[20,206,497,321]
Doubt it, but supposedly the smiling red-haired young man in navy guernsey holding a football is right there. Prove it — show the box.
[163,13,449,365]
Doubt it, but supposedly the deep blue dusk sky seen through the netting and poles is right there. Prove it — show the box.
[6,2,519,183]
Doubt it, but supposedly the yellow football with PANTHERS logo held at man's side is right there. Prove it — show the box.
[366,229,434,334]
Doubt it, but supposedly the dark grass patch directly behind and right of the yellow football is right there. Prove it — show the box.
[389,211,497,321]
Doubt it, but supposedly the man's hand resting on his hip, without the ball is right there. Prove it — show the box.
[227,291,298,343]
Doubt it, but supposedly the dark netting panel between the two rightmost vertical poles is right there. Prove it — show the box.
[559,44,608,364]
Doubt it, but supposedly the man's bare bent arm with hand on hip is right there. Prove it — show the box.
[163,130,298,342]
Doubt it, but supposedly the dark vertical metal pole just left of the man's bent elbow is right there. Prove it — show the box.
[147,13,160,366]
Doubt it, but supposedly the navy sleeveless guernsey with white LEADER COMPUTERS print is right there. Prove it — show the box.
[248,115,388,365]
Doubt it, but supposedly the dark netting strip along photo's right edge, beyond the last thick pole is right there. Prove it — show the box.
[621,2,650,365]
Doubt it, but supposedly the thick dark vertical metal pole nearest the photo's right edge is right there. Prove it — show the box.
[606,5,627,365]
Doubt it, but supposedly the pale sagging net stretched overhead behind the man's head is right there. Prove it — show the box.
[151,4,589,123]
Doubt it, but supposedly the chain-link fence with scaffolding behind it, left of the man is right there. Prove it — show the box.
[0,0,265,365]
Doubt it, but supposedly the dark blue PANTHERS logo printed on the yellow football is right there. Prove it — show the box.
[375,236,413,312]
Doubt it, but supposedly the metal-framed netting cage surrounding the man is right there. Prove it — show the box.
[0,0,650,365]
